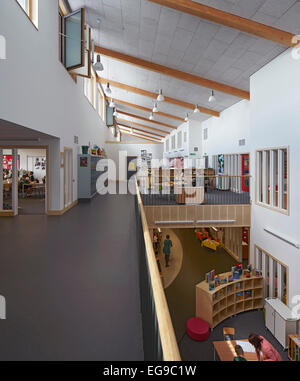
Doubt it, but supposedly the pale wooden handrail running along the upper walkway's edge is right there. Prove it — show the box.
[136,182,181,361]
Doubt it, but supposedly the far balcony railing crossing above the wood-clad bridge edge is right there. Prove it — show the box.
[138,175,251,205]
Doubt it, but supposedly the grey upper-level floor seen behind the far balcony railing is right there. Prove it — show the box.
[142,189,250,205]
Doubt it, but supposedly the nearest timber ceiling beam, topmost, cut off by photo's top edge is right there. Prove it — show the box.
[149,0,299,47]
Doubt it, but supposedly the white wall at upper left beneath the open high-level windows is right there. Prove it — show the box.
[0,0,107,209]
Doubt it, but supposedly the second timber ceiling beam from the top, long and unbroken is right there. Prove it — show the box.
[95,46,250,100]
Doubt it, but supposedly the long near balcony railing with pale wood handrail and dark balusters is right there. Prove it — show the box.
[136,180,181,361]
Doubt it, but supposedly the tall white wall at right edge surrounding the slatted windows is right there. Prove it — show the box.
[251,50,300,303]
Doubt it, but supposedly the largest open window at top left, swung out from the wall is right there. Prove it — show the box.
[63,8,92,78]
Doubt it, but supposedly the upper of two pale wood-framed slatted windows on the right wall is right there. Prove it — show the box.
[254,146,290,215]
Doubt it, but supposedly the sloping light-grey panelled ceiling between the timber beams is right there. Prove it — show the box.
[69,0,300,130]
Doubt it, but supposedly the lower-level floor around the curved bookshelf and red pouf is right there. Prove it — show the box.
[165,229,288,361]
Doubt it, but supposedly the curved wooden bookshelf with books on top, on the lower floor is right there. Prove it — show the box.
[196,272,264,329]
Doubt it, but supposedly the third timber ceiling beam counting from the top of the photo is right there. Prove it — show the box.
[98,78,220,118]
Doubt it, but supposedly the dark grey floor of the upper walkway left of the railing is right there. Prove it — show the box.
[0,195,143,360]
